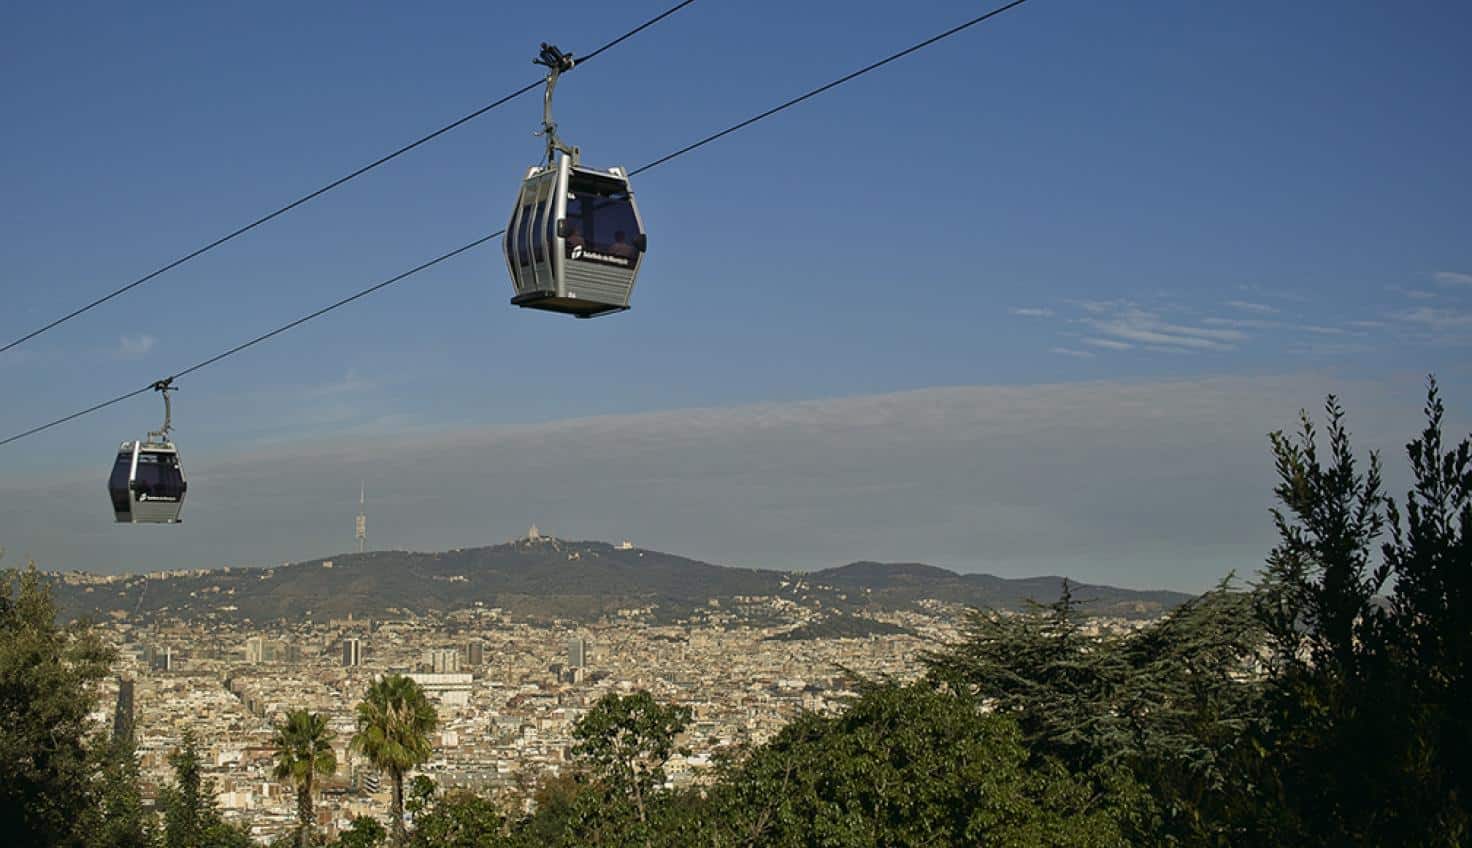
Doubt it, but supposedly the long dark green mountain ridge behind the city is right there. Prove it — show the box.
[46,536,1189,621]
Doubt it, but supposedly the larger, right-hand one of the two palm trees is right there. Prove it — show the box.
[353,674,437,845]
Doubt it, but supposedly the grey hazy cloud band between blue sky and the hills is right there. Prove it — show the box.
[0,374,1466,592]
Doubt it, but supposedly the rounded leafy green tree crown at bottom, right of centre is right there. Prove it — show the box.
[714,683,1133,848]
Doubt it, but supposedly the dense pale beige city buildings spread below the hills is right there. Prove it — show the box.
[63,529,1139,839]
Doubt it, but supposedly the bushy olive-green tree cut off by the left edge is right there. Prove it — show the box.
[0,564,112,845]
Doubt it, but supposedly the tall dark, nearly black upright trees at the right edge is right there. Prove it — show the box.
[1257,381,1472,845]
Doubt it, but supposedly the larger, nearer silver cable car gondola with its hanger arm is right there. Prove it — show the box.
[503,44,648,318]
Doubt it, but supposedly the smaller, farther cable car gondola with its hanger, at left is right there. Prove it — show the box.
[107,380,188,524]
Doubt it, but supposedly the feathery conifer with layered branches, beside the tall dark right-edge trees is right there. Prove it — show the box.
[926,580,1262,844]
